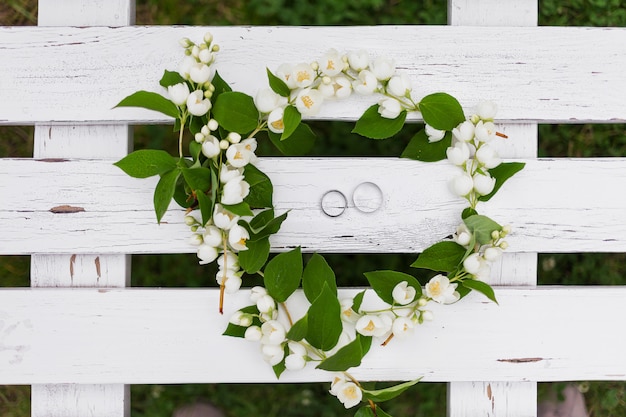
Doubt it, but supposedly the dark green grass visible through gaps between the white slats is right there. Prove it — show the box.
[0,0,626,417]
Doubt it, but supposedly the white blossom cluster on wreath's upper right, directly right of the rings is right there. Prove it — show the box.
[442,102,506,208]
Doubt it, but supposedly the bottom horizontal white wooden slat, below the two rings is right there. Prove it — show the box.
[0,287,626,384]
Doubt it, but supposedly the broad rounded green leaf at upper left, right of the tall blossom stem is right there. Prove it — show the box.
[213,91,259,134]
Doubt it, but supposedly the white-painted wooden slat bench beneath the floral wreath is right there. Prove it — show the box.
[0,0,626,417]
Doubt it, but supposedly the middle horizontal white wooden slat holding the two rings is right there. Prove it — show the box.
[0,158,626,254]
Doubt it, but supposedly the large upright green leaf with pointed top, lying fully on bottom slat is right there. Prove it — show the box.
[306,283,343,350]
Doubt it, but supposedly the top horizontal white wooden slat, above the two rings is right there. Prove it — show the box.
[0,26,626,124]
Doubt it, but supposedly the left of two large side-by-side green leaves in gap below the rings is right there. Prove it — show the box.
[263,247,302,303]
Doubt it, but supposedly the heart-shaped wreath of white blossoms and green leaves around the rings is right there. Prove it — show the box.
[116,33,524,417]
